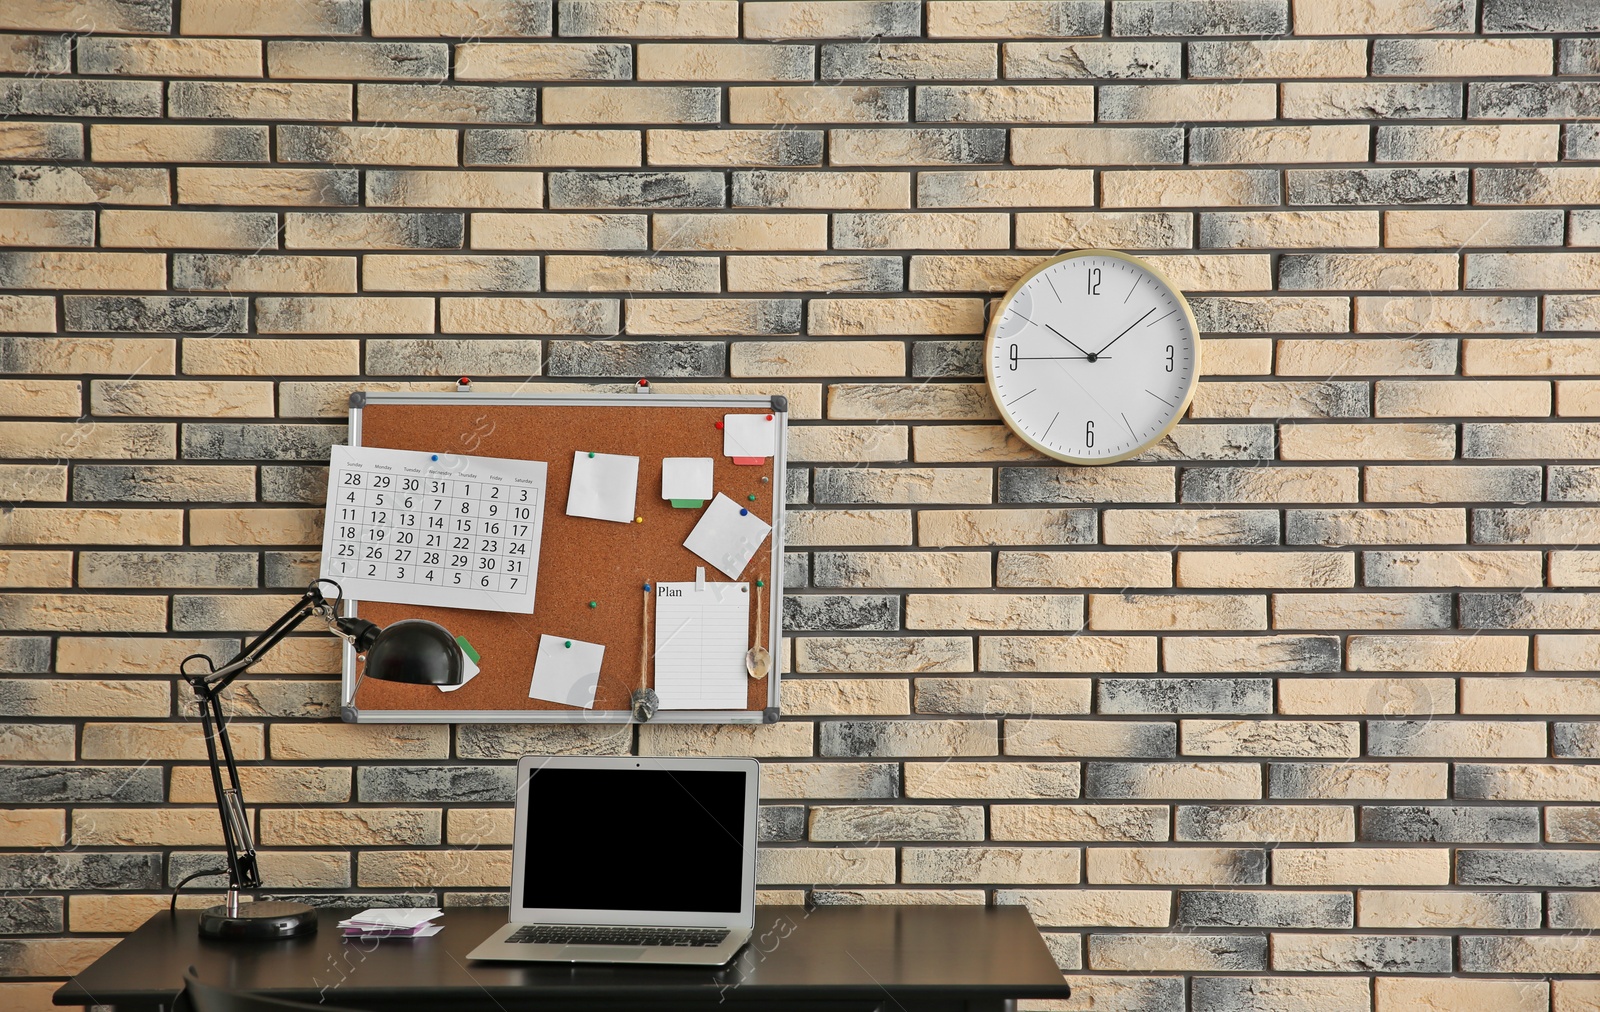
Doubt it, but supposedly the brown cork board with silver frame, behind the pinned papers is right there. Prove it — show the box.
[342,394,786,724]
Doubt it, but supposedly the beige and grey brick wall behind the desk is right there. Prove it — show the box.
[0,0,1600,1012]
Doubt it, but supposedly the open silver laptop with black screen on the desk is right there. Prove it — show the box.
[467,756,758,966]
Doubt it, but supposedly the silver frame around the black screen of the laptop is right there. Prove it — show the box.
[510,756,760,927]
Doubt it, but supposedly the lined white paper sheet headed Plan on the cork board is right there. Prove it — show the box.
[654,583,750,709]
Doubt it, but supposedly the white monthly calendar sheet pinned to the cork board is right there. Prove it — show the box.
[322,447,547,615]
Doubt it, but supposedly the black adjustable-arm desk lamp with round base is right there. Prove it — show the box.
[179,580,462,940]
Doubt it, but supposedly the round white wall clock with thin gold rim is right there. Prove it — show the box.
[984,250,1200,464]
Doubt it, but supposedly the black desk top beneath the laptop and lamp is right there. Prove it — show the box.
[54,906,1069,1012]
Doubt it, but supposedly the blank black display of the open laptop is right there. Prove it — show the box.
[523,769,746,913]
